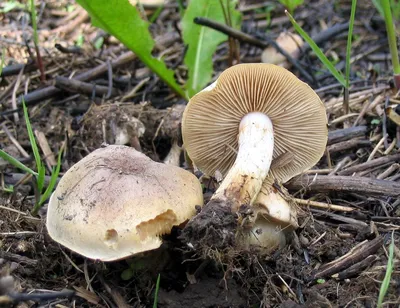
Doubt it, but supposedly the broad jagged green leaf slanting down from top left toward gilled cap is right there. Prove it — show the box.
[77,0,186,97]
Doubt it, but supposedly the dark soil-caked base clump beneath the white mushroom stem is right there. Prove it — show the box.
[180,196,286,262]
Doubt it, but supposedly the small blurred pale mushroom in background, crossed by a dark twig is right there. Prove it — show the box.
[261,32,304,68]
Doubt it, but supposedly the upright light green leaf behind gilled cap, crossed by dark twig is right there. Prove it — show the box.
[182,0,241,97]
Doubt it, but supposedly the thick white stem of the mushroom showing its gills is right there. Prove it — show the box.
[212,112,274,211]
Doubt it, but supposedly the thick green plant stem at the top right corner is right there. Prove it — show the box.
[381,0,400,89]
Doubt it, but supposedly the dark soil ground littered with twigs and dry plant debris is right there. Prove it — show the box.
[0,0,400,308]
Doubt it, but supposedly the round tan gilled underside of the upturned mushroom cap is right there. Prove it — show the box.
[182,63,328,182]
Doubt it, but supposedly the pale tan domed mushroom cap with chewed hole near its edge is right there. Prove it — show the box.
[47,145,203,261]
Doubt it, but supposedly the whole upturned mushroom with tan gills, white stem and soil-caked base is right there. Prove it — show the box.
[182,64,328,253]
